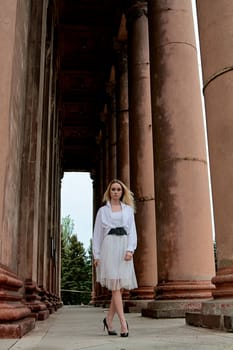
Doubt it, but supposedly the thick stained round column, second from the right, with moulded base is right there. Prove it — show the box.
[146,0,214,316]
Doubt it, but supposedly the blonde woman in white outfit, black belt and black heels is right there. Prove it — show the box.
[93,179,137,337]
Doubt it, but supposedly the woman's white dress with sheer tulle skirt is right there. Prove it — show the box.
[96,211,138,290]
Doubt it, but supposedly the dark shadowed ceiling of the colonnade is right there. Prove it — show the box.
[58,0,124,171]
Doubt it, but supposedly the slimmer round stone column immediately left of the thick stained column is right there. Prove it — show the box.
[127,1,157,299]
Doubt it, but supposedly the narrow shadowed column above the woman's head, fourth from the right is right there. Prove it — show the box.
[115,42,130,186]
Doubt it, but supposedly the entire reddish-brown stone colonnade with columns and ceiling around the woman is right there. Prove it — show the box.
[0,0,233,337]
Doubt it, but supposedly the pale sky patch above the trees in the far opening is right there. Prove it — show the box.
[61,172,93,250]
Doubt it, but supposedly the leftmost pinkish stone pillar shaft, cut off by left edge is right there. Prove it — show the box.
[0,1,30,273]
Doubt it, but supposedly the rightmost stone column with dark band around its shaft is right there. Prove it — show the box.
[197,0,233,304]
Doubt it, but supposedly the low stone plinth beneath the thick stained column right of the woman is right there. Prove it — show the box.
[142,299,207,318]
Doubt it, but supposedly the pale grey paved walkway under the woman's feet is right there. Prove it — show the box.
[0,306,233,350]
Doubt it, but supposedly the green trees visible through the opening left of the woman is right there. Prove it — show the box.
[61,216,92,305]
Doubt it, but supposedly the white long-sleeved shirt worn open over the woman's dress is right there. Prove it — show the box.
[93,202,137,259]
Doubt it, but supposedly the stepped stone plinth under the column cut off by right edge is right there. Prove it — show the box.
[185,298,233,332]
